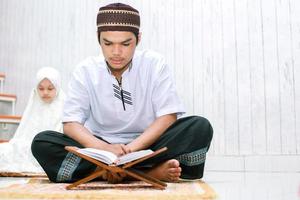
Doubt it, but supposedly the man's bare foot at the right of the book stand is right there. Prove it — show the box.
[146,159,181,182]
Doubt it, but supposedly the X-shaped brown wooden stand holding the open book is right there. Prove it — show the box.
[65,146,167,190]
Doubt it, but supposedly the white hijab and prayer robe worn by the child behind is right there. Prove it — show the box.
[0,67,65,173]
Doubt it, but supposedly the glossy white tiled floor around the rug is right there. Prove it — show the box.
[0,172,300,200]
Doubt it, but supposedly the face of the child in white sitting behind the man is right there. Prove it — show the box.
[37,78,56,103]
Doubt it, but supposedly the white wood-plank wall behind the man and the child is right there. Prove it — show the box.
[0,0,300,169]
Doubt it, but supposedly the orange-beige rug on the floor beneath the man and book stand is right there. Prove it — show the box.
[0,178,216,200]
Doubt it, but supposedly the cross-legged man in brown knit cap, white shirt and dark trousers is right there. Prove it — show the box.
[32,3,213,182]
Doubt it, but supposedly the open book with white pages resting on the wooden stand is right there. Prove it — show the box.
[77,148,153,165]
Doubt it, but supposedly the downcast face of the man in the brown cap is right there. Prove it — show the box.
[100,31,136,73]
